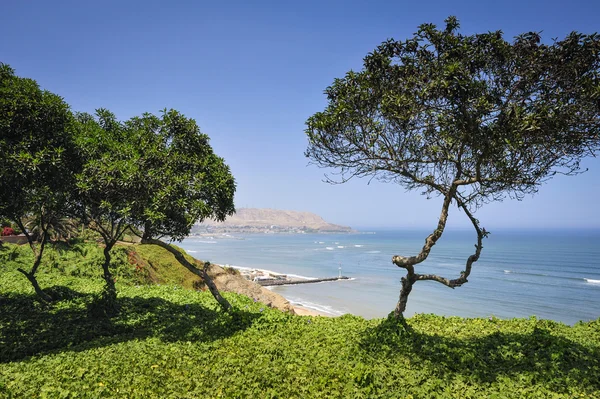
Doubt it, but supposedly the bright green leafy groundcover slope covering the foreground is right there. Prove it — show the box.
[0,242,600,398]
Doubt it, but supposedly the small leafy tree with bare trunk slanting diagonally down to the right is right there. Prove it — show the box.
[126,110,235,310]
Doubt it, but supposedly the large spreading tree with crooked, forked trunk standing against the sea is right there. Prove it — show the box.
[306,17,600,319]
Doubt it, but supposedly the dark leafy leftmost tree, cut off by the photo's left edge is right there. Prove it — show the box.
[0,63,78,301]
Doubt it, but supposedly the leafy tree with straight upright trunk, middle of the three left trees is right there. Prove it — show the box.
[76,109,147,313]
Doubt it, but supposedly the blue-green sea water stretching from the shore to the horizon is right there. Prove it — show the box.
[181,230,600,324]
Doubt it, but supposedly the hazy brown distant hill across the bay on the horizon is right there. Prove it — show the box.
[194,208,353,233]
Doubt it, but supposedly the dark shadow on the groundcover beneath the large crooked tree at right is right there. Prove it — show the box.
[360,317,600,393]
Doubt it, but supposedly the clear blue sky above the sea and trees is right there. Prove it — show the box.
[0,0,600,231]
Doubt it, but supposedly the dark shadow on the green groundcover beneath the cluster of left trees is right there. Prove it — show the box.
[0,286,260,364]
